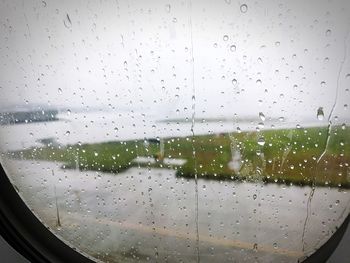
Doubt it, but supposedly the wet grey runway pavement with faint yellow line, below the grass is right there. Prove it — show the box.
[6,160,349,262]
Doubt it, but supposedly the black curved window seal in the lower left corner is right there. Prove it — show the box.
[0,164,93,263]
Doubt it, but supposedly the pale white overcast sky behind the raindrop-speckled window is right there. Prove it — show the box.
[0,0,350,124]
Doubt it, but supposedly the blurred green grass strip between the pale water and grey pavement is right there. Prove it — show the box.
[9,126,350,187]
